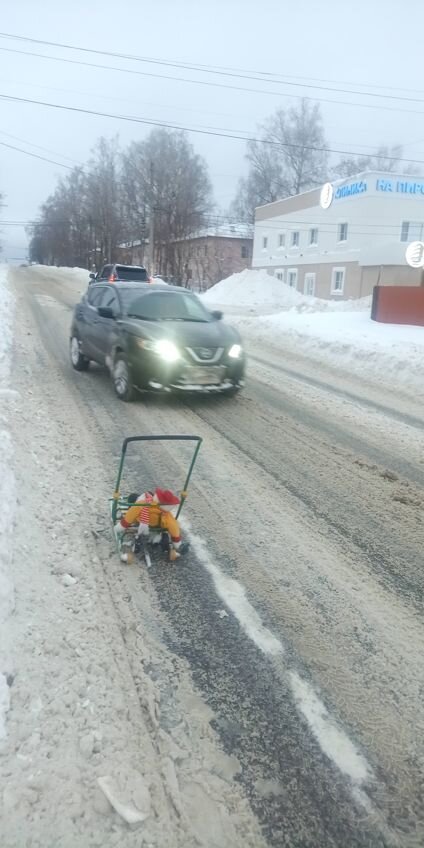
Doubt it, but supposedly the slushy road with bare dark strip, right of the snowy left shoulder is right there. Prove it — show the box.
[5,269,424,848]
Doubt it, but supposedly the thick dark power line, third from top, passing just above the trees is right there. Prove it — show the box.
[0,93,424,168]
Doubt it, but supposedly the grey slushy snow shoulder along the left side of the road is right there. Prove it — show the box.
[0,269,264,848]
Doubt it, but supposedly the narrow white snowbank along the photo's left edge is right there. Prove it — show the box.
[0,266,16,739]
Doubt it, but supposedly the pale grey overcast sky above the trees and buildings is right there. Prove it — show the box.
[0,0,424,260]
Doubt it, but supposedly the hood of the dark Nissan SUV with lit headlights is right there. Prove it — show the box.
[122,318,240,347]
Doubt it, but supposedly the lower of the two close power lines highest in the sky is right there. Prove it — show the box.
[4,47,424,120]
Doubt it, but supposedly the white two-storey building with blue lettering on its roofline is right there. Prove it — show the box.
[252,171,424,298]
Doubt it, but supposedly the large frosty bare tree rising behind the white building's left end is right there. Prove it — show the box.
[232,99,328,221]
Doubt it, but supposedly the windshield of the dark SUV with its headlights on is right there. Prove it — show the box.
[123,289,212,323]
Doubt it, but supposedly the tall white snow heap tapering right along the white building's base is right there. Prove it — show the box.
[203,270,371,314]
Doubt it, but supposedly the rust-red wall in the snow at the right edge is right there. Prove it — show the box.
[371,286,424,327]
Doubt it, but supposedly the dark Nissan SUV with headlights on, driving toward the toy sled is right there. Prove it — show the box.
[70,281,245,401]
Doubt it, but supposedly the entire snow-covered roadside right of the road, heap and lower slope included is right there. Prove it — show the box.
[204,271,424,392]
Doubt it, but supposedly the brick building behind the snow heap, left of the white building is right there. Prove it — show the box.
[174,223,253,291]
